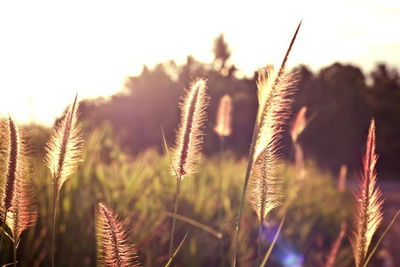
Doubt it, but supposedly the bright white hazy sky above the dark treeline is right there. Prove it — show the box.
[0,0,400,124]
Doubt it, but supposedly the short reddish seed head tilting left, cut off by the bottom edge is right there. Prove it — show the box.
[96,203,139,267]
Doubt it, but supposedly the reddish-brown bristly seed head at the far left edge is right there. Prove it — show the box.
[3,117,37,245]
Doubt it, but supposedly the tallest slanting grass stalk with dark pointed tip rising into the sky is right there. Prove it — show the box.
[231,22,301,267]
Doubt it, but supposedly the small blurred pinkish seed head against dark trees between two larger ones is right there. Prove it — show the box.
[214,95,233,137]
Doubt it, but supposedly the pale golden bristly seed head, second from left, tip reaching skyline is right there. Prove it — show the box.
[45,97,82,193]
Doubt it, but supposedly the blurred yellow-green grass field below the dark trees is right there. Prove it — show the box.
[1,126,352,266]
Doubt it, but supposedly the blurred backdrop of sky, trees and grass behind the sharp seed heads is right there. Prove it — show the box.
[0,0,400,266]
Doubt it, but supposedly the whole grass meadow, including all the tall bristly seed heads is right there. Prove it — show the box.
[0,22,400,267]
